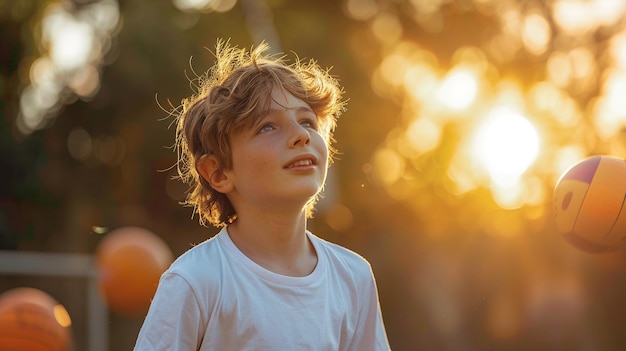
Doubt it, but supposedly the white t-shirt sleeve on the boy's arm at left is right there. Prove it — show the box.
[134,272,206,351]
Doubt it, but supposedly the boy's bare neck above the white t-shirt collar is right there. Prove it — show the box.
[228,217,317,276]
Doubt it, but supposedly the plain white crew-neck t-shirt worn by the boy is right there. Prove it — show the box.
[135,228,390,351]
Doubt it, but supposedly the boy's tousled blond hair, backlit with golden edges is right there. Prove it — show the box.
[175,40,346,227]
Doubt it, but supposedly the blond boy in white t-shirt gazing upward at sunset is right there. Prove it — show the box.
[135,42,389,351]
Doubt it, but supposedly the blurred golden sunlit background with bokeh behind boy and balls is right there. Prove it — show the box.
[0,0,626,351]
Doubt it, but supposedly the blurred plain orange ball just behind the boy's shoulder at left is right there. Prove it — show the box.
[95,227,173,316]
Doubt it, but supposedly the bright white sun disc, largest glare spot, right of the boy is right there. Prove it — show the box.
[473,107,539,186]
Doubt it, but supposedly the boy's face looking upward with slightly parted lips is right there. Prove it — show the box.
[227,88,328,211]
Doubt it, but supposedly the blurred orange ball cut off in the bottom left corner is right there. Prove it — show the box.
[0,288,72,351]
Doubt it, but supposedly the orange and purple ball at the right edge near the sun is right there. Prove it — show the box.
[554,156,626,252]
